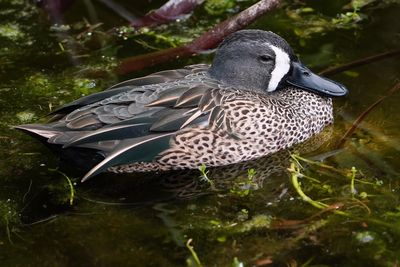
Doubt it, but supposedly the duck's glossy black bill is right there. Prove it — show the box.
[287,62,348,97]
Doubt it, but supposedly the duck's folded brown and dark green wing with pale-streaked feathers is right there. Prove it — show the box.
[19,66,232,179]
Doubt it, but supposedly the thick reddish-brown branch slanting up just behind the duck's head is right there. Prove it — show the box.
[116,0,282,74]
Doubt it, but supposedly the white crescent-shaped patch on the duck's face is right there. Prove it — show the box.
[267,45,290,92]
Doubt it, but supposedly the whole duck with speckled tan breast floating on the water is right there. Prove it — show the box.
[16,29,348,181]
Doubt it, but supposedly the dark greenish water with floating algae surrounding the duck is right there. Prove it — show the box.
[0,0,400,266]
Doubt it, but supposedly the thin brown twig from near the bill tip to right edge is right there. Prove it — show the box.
[319,49,400,76]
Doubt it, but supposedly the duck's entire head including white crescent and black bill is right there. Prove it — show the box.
[210,30,347,97]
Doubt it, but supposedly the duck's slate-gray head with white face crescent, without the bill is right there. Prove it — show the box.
[210,30,296,92]
